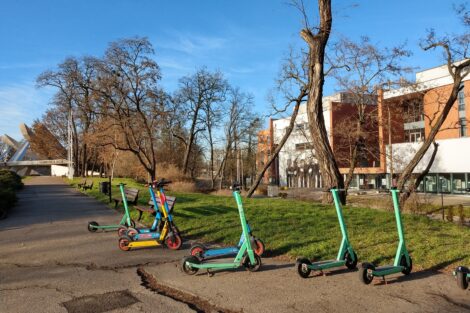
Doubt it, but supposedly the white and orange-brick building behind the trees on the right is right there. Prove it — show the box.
[258,60,470,193]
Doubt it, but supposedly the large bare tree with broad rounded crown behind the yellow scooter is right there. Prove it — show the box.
[94,38,168,180]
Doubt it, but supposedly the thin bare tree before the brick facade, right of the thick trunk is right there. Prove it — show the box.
[330,37,411,189]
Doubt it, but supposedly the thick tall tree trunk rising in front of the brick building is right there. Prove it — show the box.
[300,0,346,203]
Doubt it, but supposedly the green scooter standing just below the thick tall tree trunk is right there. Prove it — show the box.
[296,188,357,278]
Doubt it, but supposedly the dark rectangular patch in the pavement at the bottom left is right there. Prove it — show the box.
[62,290,139,313]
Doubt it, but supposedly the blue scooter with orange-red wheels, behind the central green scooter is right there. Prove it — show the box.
[190,222,264,261]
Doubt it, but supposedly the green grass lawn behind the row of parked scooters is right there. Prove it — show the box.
[72,178,470,270]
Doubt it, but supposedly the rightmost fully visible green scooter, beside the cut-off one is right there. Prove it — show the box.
[359,188,413,285]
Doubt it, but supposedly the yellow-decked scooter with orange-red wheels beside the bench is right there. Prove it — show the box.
[119,180,183,251]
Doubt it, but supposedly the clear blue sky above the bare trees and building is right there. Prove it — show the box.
[0,0,460,138]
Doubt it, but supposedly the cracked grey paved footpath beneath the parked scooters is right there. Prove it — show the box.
[0,177,470,313]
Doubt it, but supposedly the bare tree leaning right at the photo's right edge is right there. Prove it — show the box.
[397,5,470,203]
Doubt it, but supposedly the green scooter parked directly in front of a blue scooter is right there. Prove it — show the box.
[181,184,261,275]
